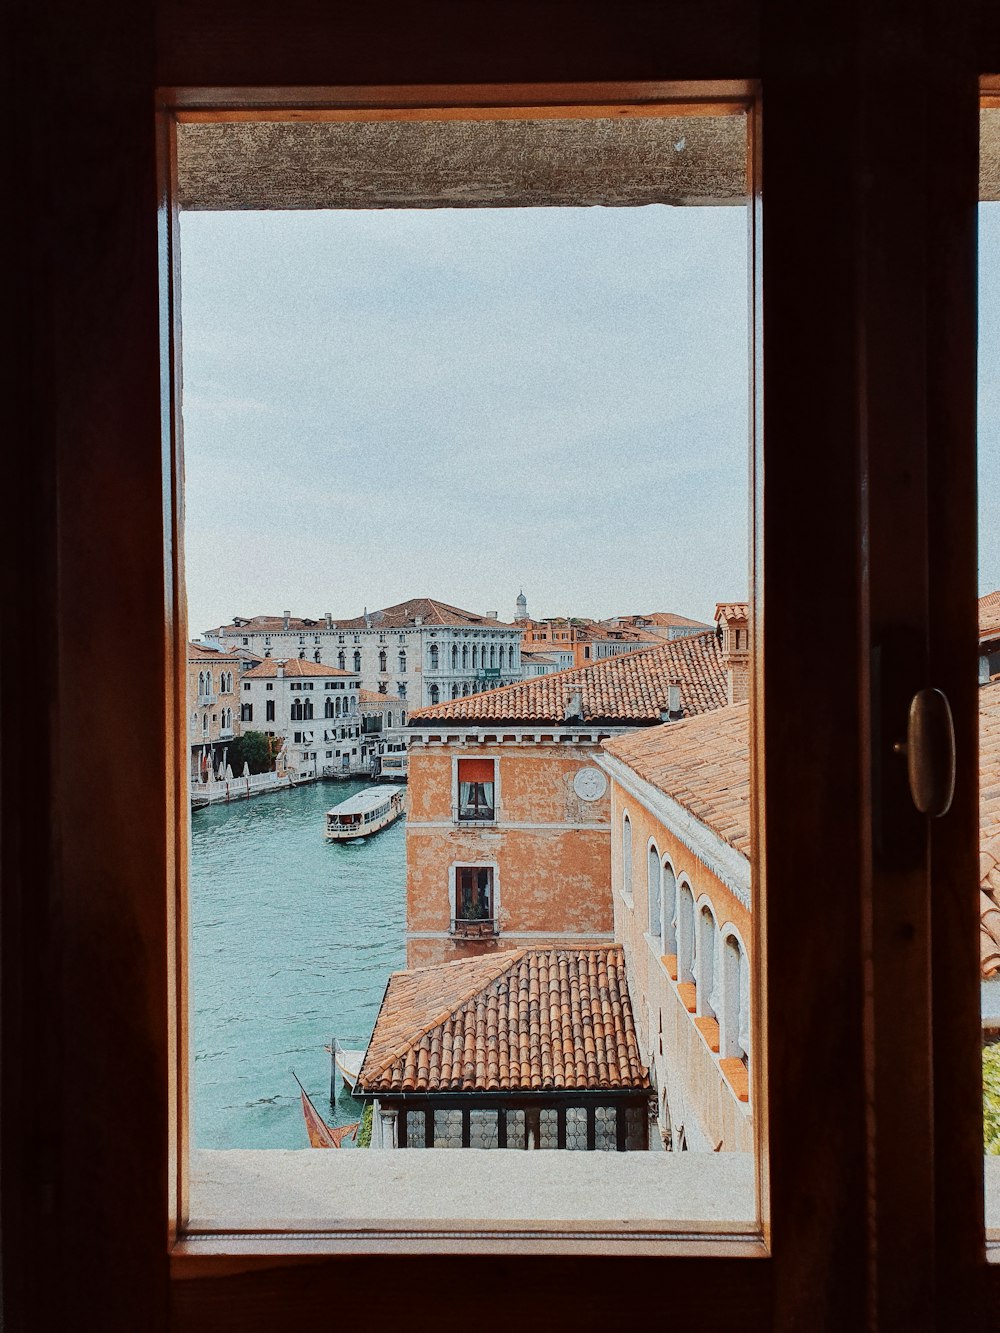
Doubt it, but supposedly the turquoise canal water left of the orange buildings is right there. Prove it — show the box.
[189,782,407,1148]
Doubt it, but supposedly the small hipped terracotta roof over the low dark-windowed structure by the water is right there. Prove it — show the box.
[357,945,649,1093]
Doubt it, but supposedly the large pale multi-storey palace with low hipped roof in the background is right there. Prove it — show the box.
[205,597,521,708]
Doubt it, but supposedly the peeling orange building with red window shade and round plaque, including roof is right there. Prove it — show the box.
[407,632,727,966]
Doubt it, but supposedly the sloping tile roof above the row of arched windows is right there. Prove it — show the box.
[604,704,751,857]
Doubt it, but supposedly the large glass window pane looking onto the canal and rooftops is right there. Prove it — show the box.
[179,104,756,1226]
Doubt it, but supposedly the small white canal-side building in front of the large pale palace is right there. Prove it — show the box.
[240,657,361,777]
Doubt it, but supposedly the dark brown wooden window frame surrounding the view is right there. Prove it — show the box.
[7,0,1000,1333]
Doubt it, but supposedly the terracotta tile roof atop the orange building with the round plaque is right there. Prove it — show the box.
[409,631,727,725]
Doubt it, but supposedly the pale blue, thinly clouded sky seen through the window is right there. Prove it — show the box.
[181,205,1000,636]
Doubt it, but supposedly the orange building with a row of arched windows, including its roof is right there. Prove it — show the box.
[601,702,753,1152]
